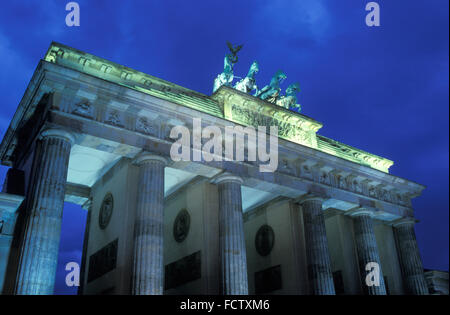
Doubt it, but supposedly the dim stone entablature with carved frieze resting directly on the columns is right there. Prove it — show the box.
[0,46,424,222]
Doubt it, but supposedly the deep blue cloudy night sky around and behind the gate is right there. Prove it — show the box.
[0,0,449,293]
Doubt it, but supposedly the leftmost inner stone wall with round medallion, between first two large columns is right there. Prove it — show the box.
[81,159,137,294]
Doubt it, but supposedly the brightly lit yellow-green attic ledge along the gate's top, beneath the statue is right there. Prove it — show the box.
[44,42,393,173]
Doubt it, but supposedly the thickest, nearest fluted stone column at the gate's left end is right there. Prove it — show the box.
[15,129,74,294]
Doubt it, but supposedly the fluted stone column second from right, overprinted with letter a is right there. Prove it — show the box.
[351,209,386,295]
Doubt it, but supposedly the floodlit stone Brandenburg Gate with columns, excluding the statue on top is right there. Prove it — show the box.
[0,43,427,294]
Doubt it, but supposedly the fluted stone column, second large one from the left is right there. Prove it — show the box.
[132,154,167,295]
